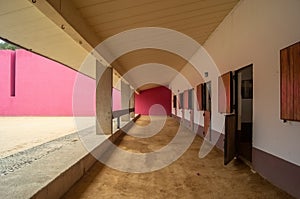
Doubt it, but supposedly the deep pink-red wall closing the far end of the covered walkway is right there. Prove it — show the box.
[135,86,172,115]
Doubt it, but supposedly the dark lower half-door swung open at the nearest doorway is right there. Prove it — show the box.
[224,115,236,165]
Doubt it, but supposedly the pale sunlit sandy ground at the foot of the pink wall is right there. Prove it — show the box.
[0,117,95,158]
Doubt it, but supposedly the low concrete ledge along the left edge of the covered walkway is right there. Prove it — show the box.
[0,115,140,199]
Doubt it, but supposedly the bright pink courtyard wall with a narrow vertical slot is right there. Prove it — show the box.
[0,50,96,116]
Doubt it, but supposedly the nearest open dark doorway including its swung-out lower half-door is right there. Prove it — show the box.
[224,64,253,165]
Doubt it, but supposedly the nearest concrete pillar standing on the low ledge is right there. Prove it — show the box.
[96,61,112,135]
